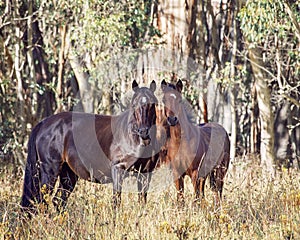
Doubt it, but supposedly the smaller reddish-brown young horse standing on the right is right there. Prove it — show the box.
[161,80,230,205]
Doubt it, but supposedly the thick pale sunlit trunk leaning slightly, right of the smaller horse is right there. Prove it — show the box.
[248,48,275,177]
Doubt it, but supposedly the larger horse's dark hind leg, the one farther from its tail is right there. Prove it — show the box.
[53,163,78,211]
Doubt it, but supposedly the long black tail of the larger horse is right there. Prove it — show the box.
[21,123,41,209]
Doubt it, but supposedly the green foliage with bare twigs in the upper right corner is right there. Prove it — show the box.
[238,0,300,101]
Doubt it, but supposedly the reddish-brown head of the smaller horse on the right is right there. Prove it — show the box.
[161,80,183,126]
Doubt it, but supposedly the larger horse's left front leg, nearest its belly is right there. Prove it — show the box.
[111,163,125,209]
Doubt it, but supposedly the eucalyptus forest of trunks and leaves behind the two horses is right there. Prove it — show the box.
[0,0,300,174]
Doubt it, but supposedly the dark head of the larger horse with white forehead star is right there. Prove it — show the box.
[131,80,158,146]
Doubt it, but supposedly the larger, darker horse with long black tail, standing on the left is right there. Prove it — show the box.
[21,81,159,210]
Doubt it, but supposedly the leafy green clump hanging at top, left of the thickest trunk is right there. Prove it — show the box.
[66,0,157,59]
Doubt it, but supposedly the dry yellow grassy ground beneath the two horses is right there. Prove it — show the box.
[0,159,300,239]
